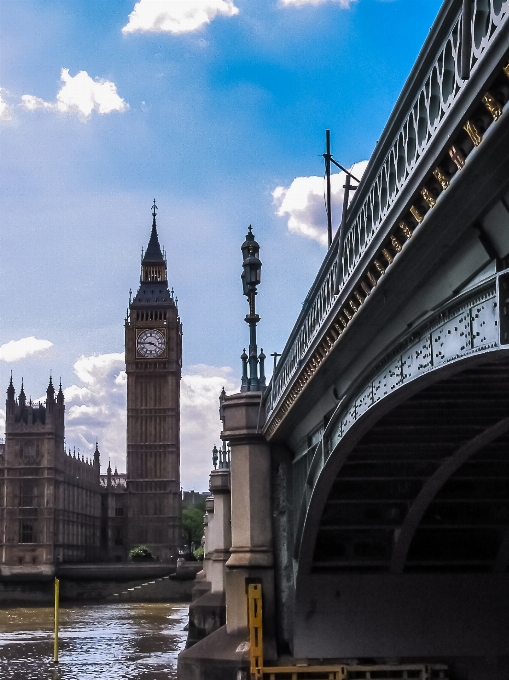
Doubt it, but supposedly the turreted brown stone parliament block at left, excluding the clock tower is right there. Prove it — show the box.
[0,378,101,575]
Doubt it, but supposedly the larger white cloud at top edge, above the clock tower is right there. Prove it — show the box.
[122,0,239,33]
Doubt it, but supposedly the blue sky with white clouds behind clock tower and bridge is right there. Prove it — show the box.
[0,0,441,489]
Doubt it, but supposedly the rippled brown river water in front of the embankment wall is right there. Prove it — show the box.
[0,602,188,680]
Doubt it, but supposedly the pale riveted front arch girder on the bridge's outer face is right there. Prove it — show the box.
[293,272,509,571]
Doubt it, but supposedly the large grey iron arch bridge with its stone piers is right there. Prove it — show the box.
[179,0,509,680]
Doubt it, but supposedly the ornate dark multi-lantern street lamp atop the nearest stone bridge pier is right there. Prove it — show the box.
[240,225,265,392]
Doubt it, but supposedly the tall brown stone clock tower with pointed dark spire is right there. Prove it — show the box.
[125,201,182,562]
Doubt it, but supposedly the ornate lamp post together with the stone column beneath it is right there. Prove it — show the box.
[220,226,276,660]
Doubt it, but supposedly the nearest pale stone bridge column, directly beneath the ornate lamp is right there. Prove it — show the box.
[221,392,276,660]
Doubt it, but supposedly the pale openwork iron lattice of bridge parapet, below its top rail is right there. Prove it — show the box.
[267,0,509,418]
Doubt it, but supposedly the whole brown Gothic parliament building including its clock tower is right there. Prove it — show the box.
[0,202,182,575]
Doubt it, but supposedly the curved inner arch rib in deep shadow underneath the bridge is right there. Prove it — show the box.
[390,417,509,573]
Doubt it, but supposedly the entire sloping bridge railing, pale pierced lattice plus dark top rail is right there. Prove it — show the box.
[266,0,509,418]
